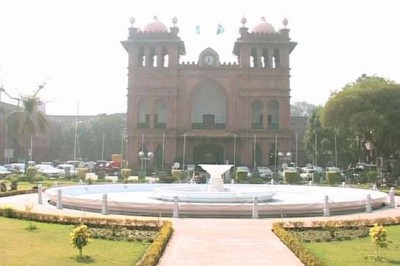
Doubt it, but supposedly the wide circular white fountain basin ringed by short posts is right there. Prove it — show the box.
[44,184,389,218]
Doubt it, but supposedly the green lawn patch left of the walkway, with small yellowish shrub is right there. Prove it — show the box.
[0,217,150,266]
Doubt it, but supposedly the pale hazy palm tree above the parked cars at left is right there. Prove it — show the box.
[6,85,49,165]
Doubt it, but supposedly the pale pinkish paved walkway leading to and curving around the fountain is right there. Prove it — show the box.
[0,194,400,266]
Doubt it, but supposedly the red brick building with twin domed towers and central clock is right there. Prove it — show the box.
[122,18,296,170]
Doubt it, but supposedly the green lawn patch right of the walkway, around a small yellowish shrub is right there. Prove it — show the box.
[304,225,400,266]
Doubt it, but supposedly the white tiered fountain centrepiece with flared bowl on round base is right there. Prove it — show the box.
[151,164,275,203]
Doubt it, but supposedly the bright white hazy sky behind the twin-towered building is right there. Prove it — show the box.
[0,0,400,115]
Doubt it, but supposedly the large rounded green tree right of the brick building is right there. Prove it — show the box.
[320,75,400,162]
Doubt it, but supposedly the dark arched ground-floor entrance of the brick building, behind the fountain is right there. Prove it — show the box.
[193,144,224,164]
